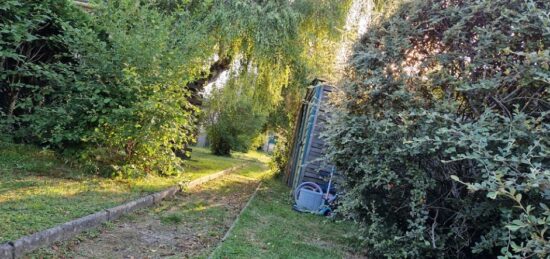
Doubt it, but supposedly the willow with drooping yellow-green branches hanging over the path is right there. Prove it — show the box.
[190,0,350,156]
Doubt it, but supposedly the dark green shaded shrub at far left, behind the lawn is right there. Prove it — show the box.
[0,0,86,141]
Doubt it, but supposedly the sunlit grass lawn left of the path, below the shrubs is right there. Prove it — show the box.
[0,142,268,243]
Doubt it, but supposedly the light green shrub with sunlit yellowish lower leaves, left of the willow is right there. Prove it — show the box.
[74,1,201,176]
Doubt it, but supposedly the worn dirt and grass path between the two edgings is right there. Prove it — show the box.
[29,175,264,258]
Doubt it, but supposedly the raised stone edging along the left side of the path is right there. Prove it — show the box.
[0,164,244,259]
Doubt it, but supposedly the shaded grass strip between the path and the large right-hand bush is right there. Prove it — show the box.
[213,178,359,258]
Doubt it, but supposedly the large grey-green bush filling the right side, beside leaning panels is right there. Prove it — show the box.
[327,0,550,258]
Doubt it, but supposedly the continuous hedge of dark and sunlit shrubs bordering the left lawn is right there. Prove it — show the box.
[0,0,198,176]
